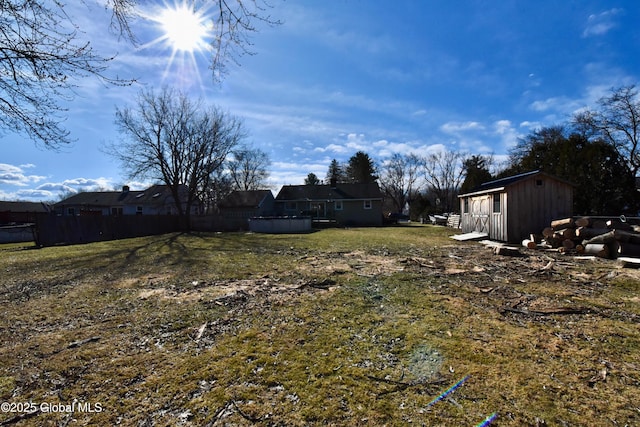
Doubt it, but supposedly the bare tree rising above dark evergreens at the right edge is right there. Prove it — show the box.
[573,85,640,176]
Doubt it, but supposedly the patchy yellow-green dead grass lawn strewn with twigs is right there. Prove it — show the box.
[0,226,640,426]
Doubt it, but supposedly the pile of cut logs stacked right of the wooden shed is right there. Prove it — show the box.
[522,217,640,258]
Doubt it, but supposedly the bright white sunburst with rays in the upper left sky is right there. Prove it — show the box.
[142,0,213,85]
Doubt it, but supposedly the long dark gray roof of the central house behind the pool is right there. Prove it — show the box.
[276,182,382,201]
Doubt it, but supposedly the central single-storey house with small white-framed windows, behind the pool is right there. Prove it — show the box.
[276,182,382,226]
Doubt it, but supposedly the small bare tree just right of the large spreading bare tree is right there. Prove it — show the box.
[227,147,271,191]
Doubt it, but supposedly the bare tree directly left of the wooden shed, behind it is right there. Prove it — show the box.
[423,151,465,212]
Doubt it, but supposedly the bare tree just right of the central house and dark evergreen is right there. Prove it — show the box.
[379,153,421,213]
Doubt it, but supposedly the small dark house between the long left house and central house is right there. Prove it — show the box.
[218,190,275,222]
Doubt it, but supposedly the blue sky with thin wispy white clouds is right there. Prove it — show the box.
[0,0,640,201]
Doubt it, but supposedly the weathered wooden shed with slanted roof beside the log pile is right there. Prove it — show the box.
[458,170,573,242]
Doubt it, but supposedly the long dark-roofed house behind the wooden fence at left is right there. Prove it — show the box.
[54,185,199,216]
